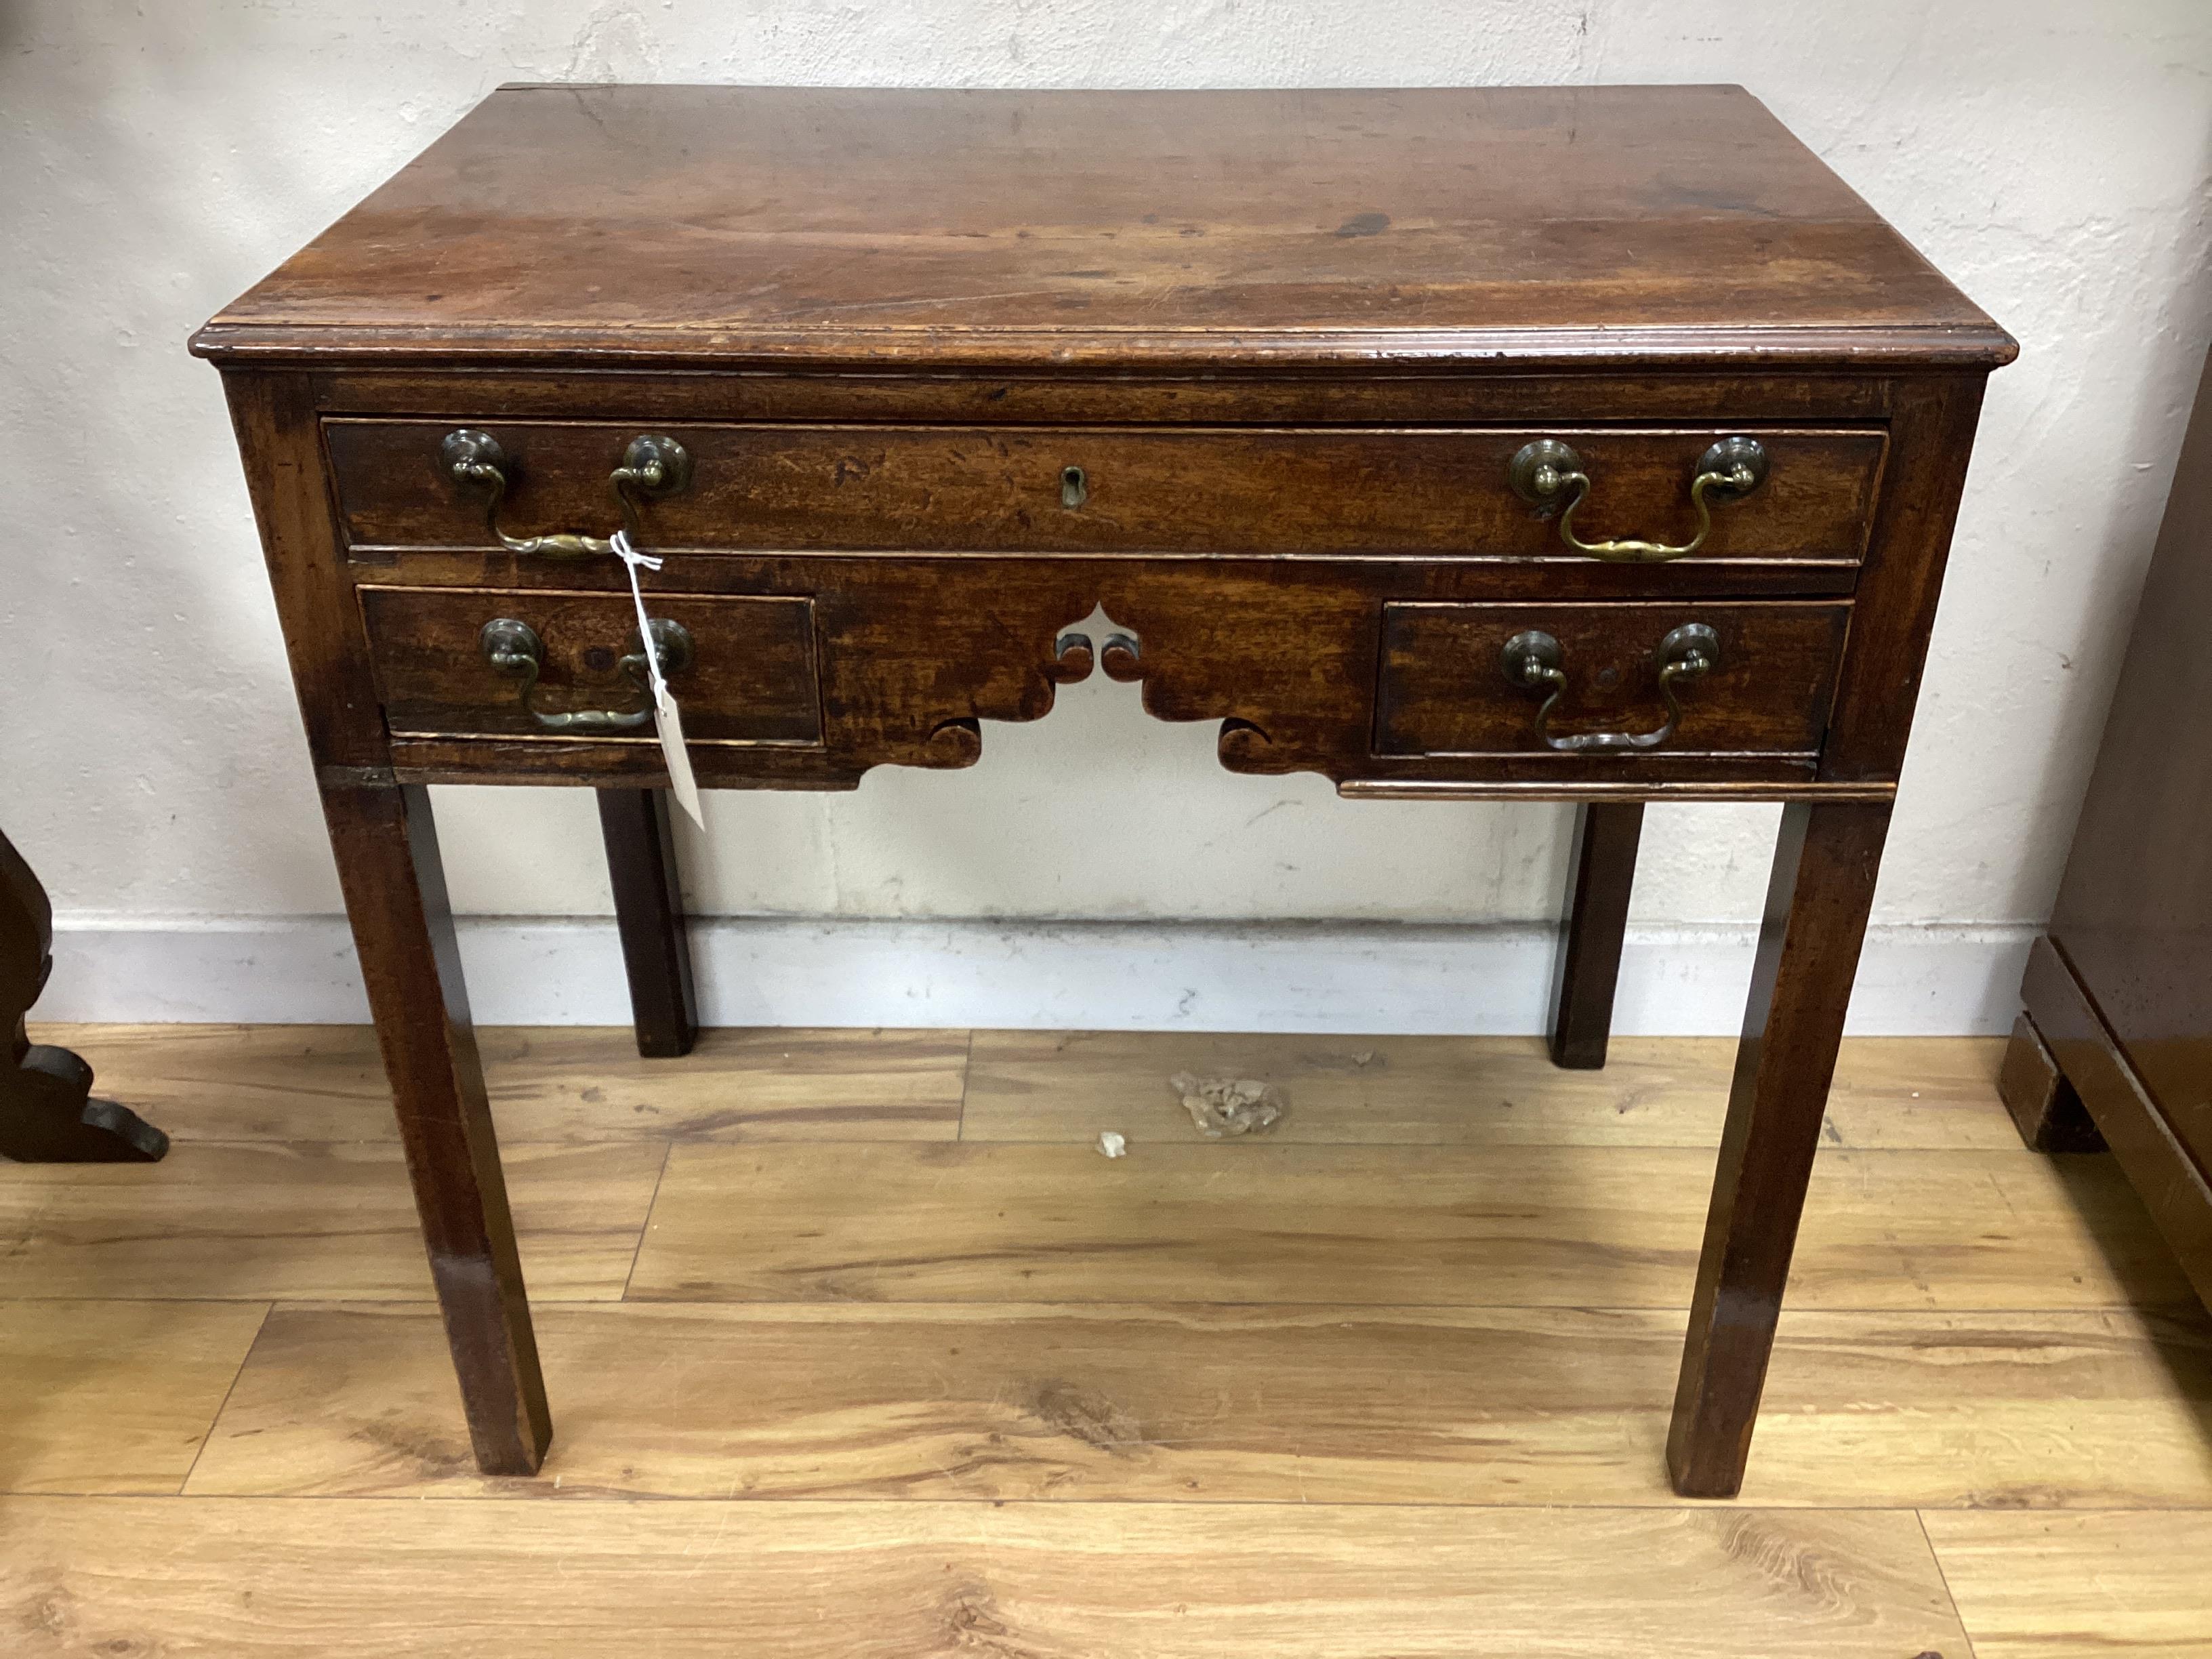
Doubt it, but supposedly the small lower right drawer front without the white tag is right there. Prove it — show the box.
[1376,602,1851,759]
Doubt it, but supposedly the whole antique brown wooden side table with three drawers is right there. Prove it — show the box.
[194,86,2015,1495]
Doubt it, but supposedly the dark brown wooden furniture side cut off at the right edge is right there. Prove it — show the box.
[2000,347,2212,1305]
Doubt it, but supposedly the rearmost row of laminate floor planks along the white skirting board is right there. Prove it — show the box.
[31,1024,2020,1153]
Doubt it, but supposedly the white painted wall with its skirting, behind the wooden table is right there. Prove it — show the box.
[0,0,2212,1029]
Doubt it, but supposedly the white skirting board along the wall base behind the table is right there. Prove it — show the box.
[33,916,2035,1036]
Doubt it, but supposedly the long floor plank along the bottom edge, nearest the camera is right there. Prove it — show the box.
[0,1500,1964,1659]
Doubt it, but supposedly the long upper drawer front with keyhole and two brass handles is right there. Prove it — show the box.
[325,420,1885,564]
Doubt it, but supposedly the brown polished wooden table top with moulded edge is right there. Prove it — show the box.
[194,86,2015,369]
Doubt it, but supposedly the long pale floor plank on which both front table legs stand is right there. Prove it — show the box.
[188,1303,2212,1509]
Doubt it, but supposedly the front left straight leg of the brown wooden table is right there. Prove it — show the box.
[323,783,553,1475]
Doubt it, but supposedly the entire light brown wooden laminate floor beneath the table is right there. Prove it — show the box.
[0,1026,2212,1659]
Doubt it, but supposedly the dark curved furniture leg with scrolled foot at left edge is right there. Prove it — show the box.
[0,836,168,1164]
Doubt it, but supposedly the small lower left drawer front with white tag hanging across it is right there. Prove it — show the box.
[359,586,823,745]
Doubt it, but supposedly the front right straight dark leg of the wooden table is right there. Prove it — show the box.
[1666,803,1889,1498]
